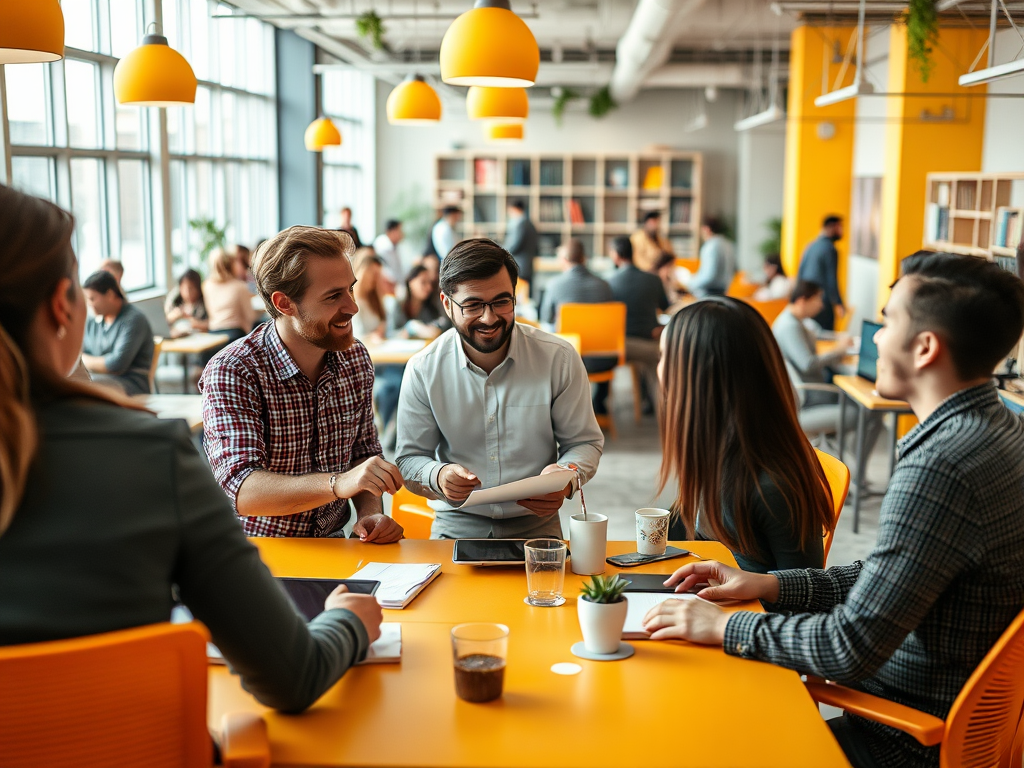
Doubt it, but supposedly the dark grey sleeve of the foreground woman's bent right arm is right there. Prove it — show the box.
[170,424,369,712]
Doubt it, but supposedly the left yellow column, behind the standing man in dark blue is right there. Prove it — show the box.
[782,27,856,290]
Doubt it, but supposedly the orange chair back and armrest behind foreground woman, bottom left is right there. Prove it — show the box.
[0,623,270,768]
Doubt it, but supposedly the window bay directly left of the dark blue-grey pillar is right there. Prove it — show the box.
[163,0,278,273]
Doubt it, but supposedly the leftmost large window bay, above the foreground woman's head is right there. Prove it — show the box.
[4,0,155,291]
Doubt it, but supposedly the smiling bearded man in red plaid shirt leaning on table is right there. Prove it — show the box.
[200,226,402,544]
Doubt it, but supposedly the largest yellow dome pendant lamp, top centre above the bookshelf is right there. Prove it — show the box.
[440,0,541,88]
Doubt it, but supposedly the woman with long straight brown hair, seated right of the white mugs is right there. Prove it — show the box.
[658,297,835,573]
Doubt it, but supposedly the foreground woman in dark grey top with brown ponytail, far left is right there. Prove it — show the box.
[0,185,381,712]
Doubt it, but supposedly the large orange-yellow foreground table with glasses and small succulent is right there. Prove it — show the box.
[208,539,848,768]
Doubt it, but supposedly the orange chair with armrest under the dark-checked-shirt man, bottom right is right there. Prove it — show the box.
[807,611,1024,768]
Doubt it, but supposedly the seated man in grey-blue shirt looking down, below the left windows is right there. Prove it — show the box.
[82,269,155,394]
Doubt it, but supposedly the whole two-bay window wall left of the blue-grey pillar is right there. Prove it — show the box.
[0,0,278,291]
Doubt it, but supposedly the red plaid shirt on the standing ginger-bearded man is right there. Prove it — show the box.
[200,322,381,537]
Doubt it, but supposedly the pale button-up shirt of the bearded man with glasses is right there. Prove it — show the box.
[395,324,604,538]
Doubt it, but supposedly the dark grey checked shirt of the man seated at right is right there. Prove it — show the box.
[725,384,1024,768]
